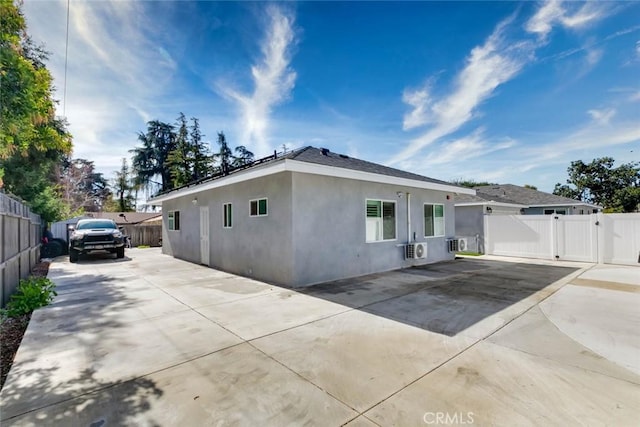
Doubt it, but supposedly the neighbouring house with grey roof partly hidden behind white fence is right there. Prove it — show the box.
[455,184,602,253]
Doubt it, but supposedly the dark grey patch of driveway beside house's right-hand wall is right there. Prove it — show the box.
[299,258,577,336]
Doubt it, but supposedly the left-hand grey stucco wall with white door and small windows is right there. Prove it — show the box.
[162,172,293,284]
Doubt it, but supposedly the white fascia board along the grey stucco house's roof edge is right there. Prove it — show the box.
[147,159,476,205]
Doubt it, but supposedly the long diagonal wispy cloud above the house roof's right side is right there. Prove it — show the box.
[390,16,532,164]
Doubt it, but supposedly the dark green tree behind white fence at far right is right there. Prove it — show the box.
[553,157,640,212]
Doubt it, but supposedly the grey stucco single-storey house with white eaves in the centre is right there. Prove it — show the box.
[148,147,474,286]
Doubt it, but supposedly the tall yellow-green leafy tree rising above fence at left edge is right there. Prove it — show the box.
[0,0,71,222]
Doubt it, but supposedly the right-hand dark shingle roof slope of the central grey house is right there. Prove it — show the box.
[285,146,456,187]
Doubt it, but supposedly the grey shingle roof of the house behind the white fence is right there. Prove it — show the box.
[470,184,595,207]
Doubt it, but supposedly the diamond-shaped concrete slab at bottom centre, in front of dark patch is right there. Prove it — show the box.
[252,311,473,411]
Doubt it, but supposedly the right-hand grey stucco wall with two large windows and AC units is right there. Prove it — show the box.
[292,173,455,286]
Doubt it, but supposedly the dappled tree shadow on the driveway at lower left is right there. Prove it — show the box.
[0,270,162,426]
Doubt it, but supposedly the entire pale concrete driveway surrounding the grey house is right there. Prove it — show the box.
[1,249,640,427]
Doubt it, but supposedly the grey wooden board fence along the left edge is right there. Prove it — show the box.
[0,193,42,307]
